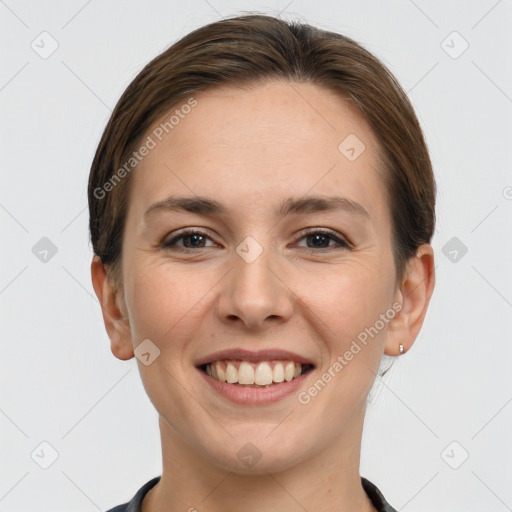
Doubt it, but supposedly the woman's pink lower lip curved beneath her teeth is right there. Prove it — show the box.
[198,368,312,405]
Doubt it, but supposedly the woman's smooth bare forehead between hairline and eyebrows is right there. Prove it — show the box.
[126,82,384,221]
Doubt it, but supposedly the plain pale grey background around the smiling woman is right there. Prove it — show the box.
[0,0,512,512]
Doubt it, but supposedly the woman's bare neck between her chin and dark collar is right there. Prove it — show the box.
[142,410,375,512]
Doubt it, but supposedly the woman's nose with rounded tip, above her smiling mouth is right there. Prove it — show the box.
[217,241,295,330]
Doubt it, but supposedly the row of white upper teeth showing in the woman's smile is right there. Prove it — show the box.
[206,361,302,386]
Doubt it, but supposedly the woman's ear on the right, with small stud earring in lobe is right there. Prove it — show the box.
[384,244,435,356]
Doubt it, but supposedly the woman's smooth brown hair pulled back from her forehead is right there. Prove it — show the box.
[88,14,435,288]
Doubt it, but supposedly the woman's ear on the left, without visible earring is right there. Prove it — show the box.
[91,255,134,361]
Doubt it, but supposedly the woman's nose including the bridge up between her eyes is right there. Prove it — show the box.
[219,235,292,328]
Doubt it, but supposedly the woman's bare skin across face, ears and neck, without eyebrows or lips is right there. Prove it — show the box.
[91,82,434,512]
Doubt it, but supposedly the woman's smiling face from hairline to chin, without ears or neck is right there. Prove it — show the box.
[115,82,396,473]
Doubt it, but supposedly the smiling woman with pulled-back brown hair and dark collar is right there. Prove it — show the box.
[89,15,435,512]
